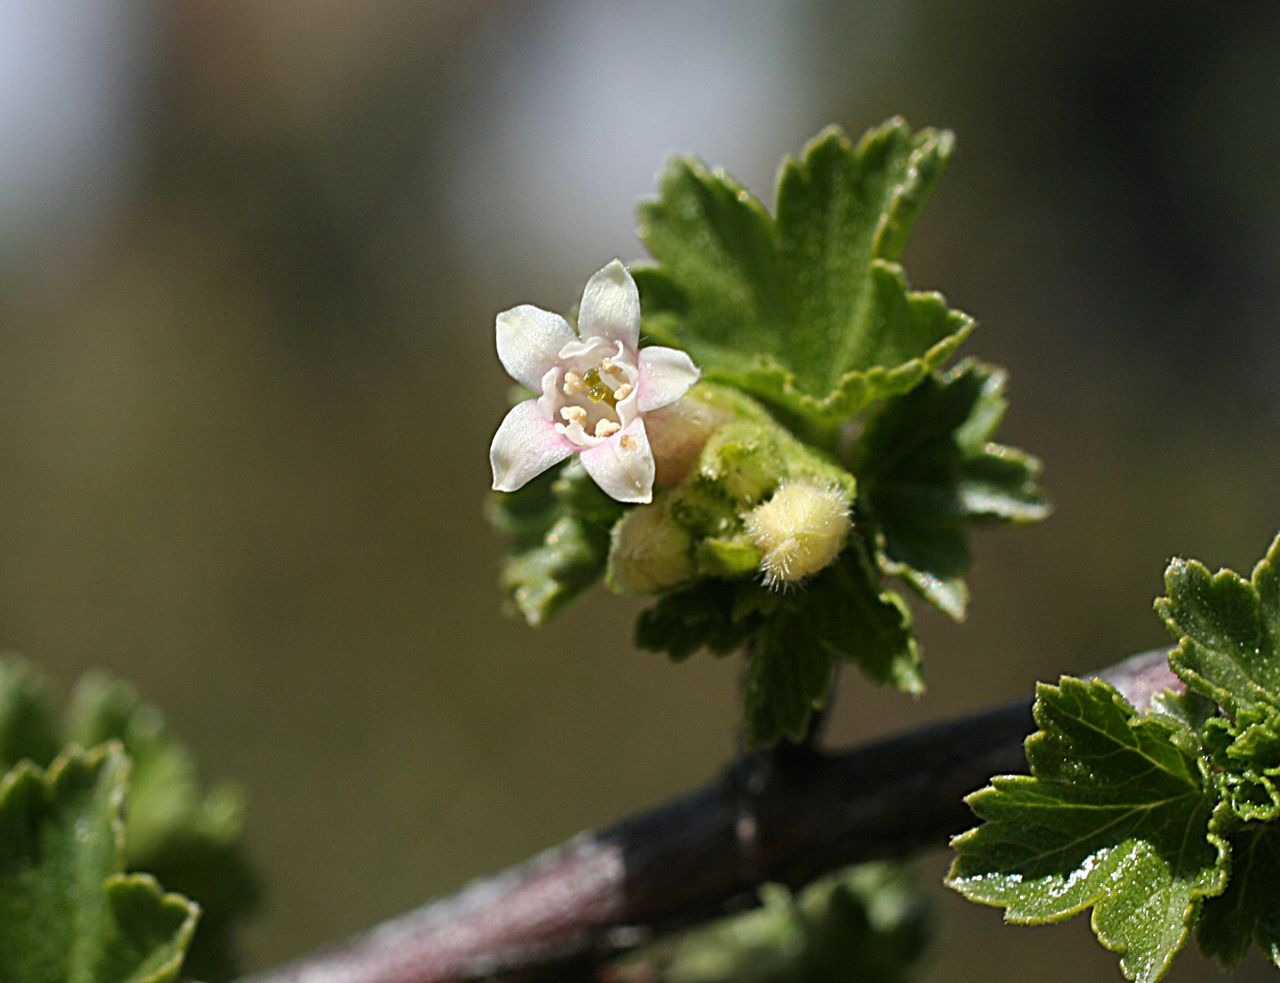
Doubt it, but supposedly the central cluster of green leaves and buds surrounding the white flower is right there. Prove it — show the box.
[489,119,1048,746]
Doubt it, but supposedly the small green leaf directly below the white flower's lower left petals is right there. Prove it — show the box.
[486,461,622,625]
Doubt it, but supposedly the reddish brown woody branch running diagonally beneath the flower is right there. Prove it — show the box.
[242,650,1180,983]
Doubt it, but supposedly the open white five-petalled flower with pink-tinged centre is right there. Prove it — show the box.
[489,260,700,502]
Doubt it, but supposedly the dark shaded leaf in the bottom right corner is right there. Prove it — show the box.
[1196,823,1280,968]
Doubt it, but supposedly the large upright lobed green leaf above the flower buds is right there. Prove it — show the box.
[632,119,973,424]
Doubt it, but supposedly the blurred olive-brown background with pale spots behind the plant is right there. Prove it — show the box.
[0,0,1280,983]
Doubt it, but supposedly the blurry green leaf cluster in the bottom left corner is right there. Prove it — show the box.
[0,657,259,983]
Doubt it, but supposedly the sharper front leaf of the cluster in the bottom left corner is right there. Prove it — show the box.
[0,744,198,983]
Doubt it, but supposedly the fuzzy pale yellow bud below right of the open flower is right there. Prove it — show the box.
[746,481,849,586]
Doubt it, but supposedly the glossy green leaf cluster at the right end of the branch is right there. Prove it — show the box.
[950,536,1280,982]
